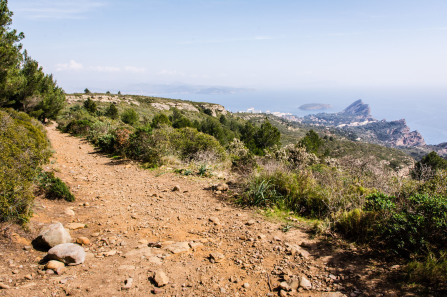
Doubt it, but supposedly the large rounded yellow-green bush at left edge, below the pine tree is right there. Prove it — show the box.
[0,110,51,224]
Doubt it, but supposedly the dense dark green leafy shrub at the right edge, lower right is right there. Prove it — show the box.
[365,194,447,257]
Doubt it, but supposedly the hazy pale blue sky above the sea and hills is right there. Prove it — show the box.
[9,0,447,92]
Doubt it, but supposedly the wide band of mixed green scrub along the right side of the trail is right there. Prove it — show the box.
[59,93,447,287]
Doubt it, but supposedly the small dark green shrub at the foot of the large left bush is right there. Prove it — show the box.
[39,172,75,202]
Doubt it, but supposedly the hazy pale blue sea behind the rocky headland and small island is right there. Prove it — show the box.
[150,89,447,145]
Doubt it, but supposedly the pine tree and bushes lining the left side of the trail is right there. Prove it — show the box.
[0,0,74,224]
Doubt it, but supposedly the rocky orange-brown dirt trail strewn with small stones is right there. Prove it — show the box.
[0,126,386,296]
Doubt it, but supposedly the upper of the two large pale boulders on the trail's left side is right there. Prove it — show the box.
[32,223,71,250]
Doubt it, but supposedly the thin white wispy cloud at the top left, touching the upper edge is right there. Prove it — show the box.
[11,0,106,19]
